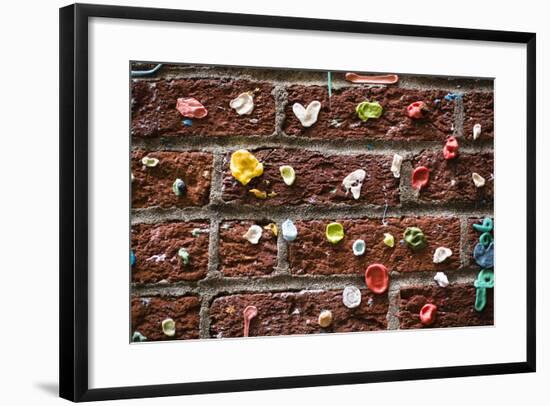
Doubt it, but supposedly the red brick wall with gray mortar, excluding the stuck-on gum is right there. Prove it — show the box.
[130,64,494,340]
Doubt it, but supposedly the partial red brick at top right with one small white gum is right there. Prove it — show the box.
[463,92,495,140]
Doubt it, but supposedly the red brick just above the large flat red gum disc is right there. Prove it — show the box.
[289,217,460,277]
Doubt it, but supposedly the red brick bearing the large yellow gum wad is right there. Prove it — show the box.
[223,149,400,206]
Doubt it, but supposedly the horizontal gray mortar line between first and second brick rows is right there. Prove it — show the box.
[132,135,493,155]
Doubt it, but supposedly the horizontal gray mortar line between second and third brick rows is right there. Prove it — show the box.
[132,204,493,225]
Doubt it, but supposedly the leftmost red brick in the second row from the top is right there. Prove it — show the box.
[132,150,212,208]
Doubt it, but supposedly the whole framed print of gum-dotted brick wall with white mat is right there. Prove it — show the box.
[60,5,536,401]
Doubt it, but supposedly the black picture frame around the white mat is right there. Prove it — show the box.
[59,4,536,402]
